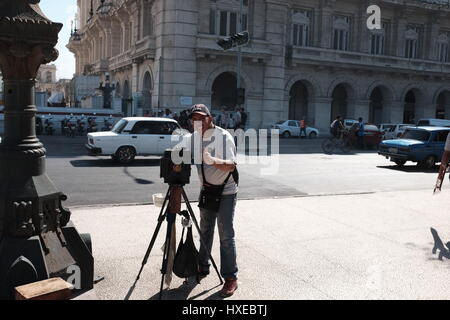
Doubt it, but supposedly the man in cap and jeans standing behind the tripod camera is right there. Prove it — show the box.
[190,104,239,297]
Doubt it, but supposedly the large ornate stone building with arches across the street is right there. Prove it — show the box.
[68,0,450,131]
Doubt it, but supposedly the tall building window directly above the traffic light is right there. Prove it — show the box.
[209,0,248,36]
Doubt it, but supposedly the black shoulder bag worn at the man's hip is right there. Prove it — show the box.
[198,163,239,212]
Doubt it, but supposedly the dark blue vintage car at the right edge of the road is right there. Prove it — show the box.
[378,127,450,169]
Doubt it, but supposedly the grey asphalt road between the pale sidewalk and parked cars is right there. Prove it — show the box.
[40,136,437,207]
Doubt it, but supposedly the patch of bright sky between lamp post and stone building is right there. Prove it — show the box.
[40,0,77,79]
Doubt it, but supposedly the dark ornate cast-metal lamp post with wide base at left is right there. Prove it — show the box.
[0,0,94,299]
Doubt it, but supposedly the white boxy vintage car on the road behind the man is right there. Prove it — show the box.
[85,117,185,164]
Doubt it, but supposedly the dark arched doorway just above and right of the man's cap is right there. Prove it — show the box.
[211,72,237,110]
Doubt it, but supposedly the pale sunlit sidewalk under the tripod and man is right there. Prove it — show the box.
[72,188,450,300]
